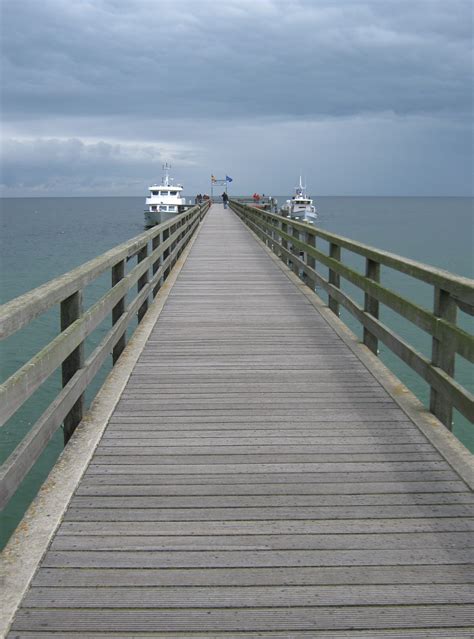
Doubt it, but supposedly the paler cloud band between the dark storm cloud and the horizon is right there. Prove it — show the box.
[3,113,472,195]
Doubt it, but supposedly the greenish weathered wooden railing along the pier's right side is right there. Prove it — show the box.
[230,200,474,429]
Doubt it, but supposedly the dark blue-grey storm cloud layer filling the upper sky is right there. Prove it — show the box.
[3,0,471,119]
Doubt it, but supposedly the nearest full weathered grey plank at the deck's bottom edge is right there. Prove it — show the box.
[12,604,474,636]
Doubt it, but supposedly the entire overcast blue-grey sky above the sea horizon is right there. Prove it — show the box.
[0,0,473,196]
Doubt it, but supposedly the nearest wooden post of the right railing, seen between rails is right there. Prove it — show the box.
[430,286,457,430]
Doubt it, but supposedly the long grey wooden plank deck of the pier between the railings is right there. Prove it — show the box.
[9,205,474,639]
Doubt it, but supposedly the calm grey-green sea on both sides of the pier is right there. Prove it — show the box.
[0,196,474,546]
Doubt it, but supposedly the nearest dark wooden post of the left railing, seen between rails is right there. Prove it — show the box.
[61,291,84,444]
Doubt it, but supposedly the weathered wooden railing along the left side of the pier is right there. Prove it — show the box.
[0,203,209,507]
